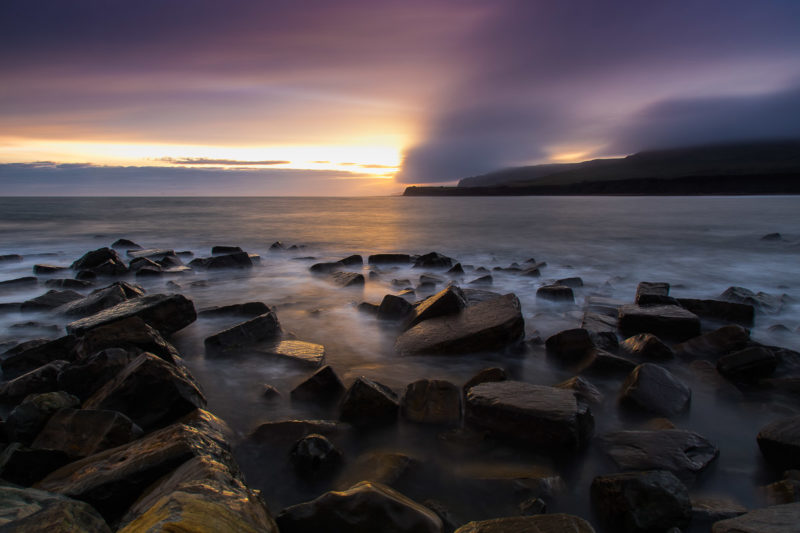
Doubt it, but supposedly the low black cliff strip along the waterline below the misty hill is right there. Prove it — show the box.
[403,174,800,196]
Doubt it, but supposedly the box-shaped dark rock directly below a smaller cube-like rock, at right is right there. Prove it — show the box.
[619,305,700,341]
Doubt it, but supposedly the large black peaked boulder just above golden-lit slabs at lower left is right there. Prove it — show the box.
[83,352,206,431]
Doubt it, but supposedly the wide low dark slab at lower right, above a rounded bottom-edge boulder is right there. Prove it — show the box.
[599,429,719,485]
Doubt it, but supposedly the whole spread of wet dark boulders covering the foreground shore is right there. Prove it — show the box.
[0,239,800,533]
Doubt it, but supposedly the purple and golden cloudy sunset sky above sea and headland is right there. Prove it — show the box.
[0,0,800,196]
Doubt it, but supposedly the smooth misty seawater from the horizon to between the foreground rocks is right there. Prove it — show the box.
[0,196,800,520]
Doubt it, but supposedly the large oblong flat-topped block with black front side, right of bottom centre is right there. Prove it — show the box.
[464,381,594,451]
